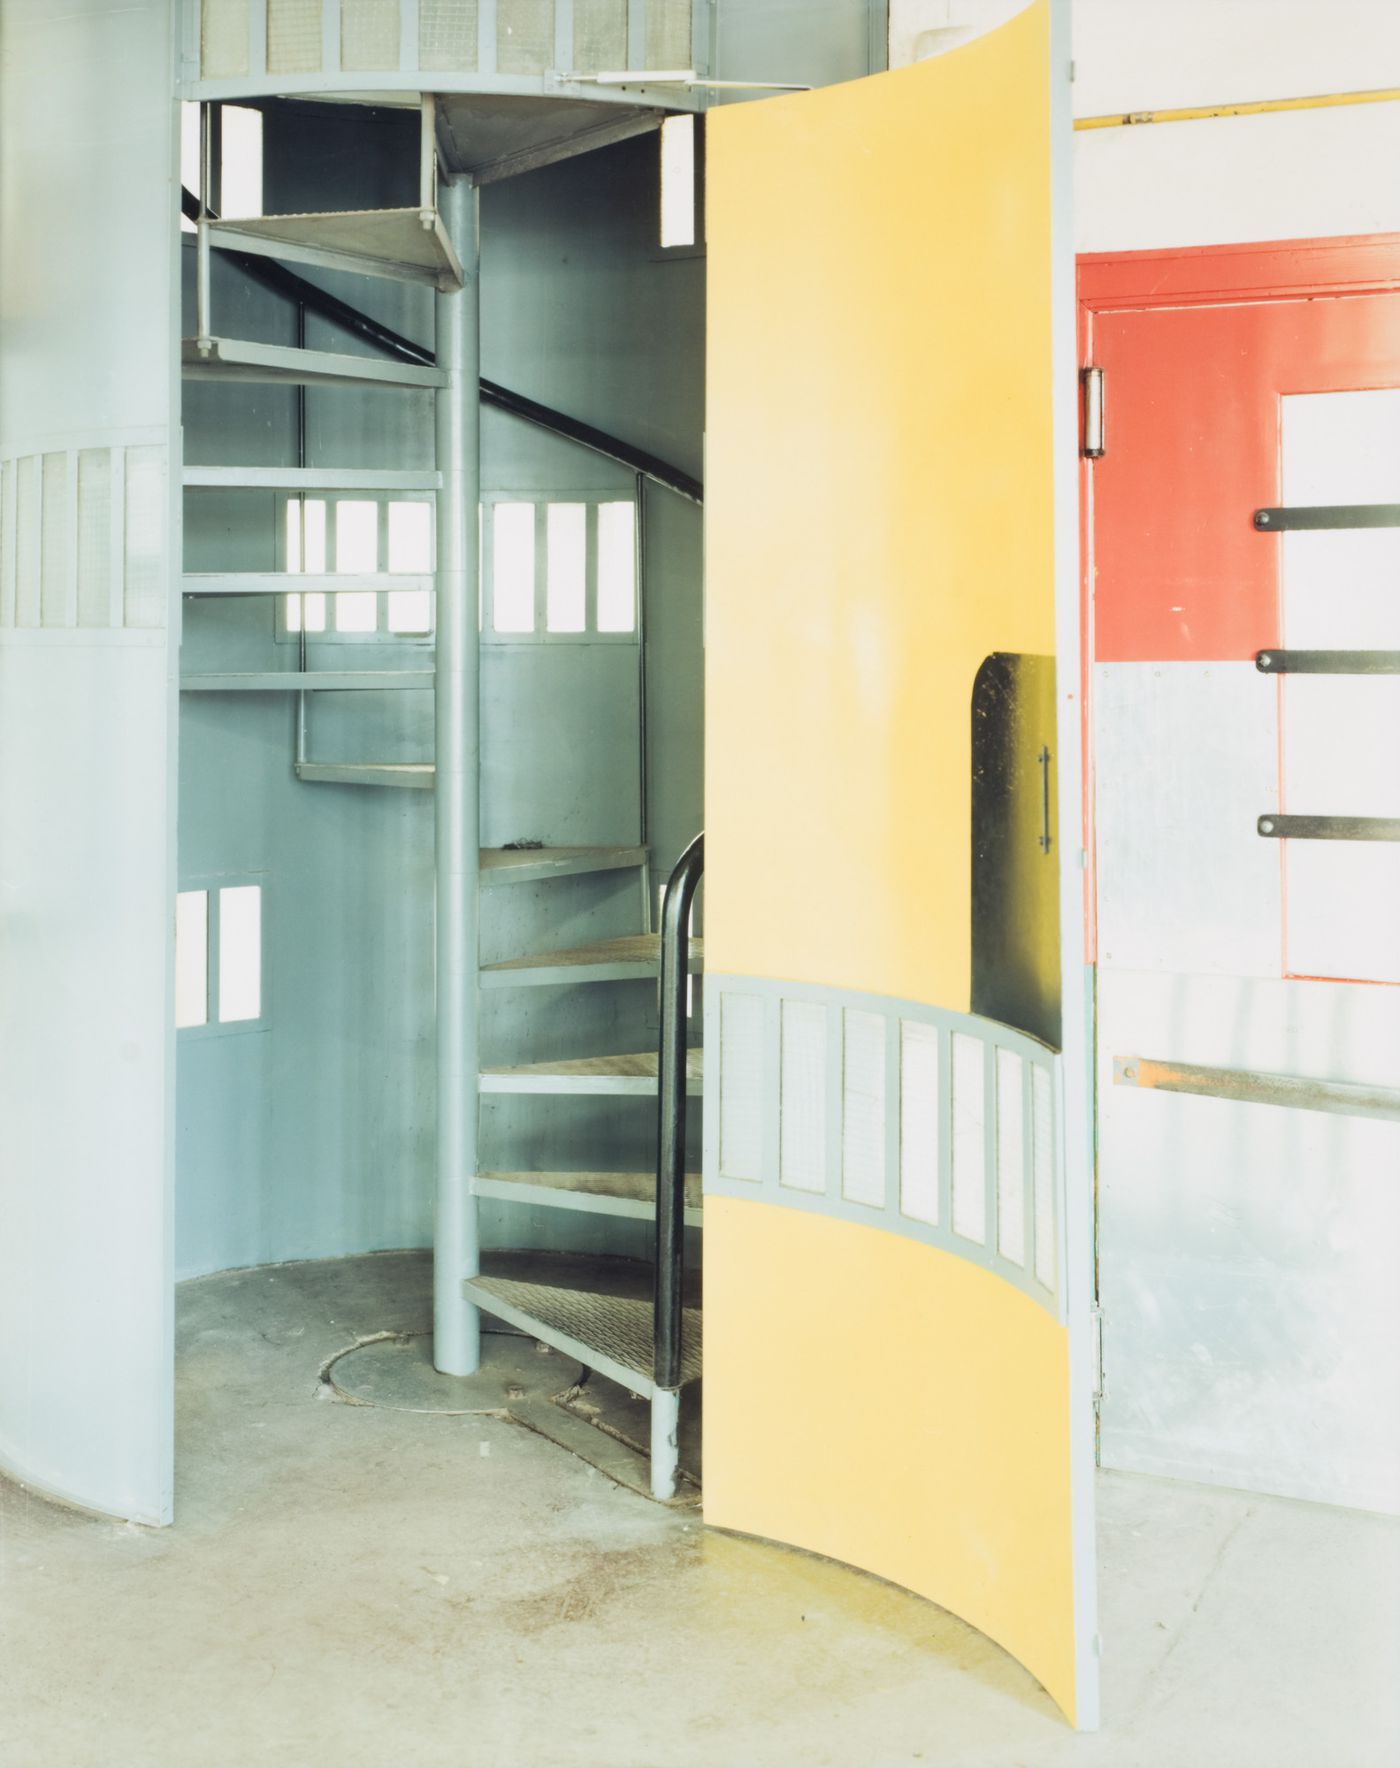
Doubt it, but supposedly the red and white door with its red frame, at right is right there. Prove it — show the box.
[1080,239,1400,1510]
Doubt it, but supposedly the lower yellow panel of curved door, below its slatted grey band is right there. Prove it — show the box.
[705,1197,1075,1724]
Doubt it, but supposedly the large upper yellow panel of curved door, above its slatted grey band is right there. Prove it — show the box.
[705,0,1055,1011]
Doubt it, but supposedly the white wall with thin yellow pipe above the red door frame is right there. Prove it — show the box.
[889,0,1400,251]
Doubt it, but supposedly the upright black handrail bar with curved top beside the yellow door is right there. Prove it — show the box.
[654,833,705,1391]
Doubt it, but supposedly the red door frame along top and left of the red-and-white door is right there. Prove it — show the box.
[1077,233,1400,964]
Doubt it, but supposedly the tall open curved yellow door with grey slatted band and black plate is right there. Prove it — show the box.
[705,0,1098,1726]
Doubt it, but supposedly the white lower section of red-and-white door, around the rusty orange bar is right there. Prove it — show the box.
[1098,971,1400,1512]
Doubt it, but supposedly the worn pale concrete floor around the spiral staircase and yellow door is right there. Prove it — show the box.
[0,1254,1400,1768]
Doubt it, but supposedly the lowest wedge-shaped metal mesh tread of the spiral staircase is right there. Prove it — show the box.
[463,1276,702,1393]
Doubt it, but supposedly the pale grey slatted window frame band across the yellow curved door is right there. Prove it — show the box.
[705,972,1066,1321]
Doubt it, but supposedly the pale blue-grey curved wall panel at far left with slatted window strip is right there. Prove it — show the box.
[0,0,179,1522]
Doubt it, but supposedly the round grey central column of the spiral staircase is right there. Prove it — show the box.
[433,179,481,1376]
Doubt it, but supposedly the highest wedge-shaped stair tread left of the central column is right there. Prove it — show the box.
[207,207,461,293]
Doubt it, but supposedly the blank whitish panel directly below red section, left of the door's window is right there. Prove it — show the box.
[1092,663,1282,976]
